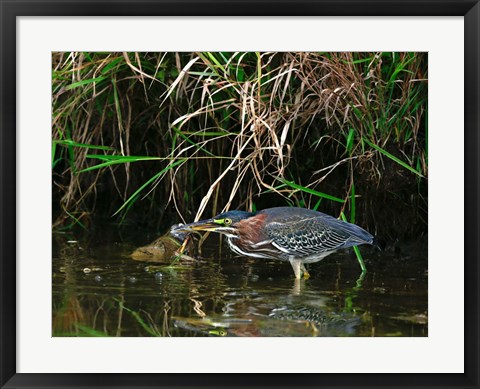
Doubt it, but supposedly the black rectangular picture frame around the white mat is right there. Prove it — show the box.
[0,0,480,388]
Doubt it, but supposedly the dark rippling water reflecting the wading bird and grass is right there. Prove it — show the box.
[52,228,428,337]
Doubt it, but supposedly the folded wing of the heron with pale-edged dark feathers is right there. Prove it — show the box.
[266,217,351,257]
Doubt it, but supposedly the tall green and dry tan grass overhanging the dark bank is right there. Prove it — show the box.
[52,52,428,237]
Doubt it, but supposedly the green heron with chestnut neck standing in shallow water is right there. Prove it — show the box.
[175,207,374,279]
